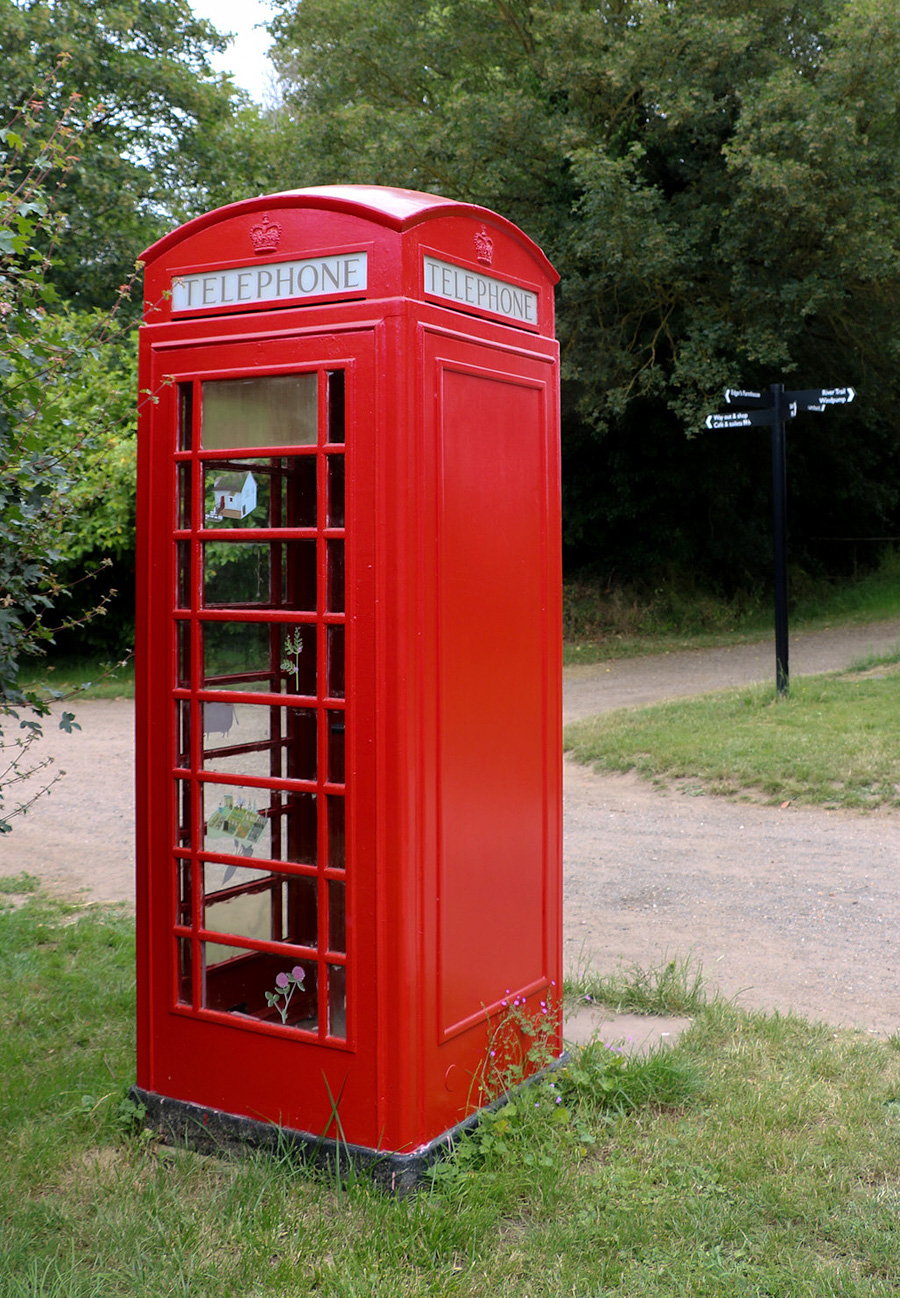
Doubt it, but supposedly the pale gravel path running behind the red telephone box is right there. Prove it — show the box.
[0,622,900,1045]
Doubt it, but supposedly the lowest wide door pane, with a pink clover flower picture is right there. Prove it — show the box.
[201,942,318,1032]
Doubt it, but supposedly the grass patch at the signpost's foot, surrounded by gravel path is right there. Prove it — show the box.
[565,653,900,810]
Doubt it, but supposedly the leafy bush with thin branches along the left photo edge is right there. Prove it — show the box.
[0,83,129,833]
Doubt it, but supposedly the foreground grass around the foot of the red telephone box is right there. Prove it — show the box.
[0,880,900,1298]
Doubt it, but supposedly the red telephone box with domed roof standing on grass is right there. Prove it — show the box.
[136,186,561,1176]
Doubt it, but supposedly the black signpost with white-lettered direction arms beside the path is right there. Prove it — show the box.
[706,383,856,694]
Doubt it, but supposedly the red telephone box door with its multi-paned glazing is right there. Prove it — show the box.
[139,330,378,1142]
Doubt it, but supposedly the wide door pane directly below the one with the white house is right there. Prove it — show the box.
[203,540,316,613]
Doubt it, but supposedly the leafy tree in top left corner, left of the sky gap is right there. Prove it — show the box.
[0,0,240,308]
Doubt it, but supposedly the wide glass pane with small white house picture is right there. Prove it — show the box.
[203,454,317,527]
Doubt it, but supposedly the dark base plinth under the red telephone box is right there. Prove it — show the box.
[130,1054,568,1194]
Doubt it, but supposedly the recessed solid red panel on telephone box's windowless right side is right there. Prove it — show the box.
[435,362,552,1033]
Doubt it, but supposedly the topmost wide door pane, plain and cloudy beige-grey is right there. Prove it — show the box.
[200,374,318,450]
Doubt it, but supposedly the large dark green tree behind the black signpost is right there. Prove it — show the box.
[266,0,900,584]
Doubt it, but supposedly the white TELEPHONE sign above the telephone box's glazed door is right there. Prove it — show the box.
[171,252,369,315]
